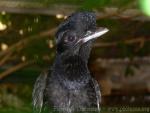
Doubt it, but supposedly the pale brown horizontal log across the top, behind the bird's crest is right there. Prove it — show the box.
[0,0,150,21]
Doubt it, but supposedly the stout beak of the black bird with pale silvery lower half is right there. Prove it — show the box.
[79,27,109,43]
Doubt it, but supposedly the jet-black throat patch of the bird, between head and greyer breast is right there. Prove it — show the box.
[55,55,89,82]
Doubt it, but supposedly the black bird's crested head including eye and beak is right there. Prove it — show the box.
[56,12,108,61]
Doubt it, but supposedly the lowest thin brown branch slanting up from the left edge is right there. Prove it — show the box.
[0,61,33,80]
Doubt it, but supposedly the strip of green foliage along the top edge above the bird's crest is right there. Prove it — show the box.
[32,0,134,10]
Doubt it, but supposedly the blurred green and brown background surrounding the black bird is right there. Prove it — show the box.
[0,0,150,113]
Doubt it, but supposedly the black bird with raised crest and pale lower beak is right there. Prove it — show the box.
[33,12,108,113]
